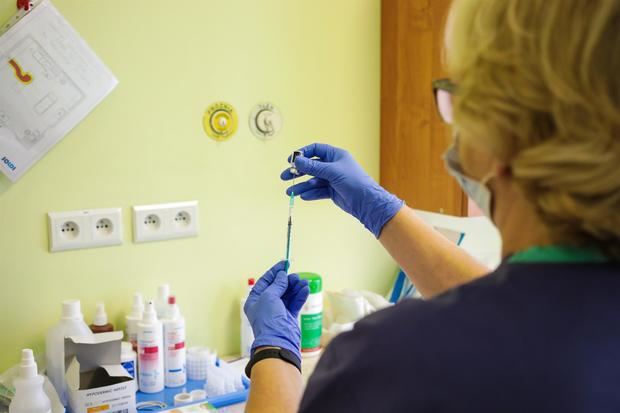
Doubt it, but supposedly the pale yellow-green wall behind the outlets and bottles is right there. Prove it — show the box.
[0,0,395,371]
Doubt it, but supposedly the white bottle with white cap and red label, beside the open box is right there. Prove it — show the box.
[138,301,164,393]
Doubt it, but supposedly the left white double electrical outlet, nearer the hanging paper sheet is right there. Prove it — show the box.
[47,208,123,252]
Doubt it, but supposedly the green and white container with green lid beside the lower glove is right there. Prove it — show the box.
[299,272,323,356]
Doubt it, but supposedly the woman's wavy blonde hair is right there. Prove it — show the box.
[446,0,620,259]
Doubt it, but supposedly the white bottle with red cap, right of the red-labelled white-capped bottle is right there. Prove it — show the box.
[164,295,187,387]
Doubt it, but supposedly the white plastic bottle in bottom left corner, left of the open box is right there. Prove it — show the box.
[9,349,52,413]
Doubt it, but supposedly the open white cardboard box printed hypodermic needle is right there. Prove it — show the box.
[65,331,136,413]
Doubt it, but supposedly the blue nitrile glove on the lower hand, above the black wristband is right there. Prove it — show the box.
[243,261,310,361]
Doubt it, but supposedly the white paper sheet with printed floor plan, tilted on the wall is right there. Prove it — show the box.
[0,0,118,182]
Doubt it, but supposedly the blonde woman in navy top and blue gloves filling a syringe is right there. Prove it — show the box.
[245,0,620,413]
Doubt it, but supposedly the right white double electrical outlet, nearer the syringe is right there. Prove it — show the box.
[133,201,199,242]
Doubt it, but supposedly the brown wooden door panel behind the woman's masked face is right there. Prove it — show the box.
[381,0,467,216]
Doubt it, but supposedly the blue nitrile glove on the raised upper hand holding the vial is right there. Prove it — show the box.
[281,143,403,238]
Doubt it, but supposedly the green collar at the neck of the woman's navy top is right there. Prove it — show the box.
[508,245,609,264]
